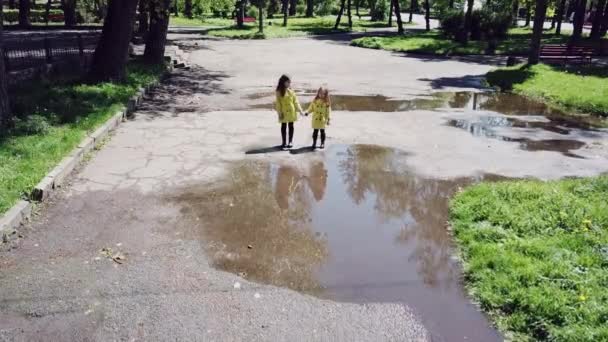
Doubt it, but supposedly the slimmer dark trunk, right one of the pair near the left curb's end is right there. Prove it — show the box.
[144,0,171,64]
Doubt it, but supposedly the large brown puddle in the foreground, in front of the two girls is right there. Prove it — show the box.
[173,145,500,341]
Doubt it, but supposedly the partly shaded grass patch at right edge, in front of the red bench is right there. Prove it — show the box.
[486,64,608,117]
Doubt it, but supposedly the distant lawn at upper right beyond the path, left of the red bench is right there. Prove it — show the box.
[352,27,568,55]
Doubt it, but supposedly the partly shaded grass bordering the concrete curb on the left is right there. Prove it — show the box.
[0,64,162,215]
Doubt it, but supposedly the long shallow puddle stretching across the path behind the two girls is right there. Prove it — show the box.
[248,91,605,158]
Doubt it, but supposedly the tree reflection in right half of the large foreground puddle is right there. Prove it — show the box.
[340,145,466,285]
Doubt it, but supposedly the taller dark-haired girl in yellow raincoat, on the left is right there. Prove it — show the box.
[275,75,302,149]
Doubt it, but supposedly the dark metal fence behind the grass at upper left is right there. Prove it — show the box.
[2,34,99,72]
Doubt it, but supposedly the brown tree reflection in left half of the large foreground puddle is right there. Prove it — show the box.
[170,163,327,292]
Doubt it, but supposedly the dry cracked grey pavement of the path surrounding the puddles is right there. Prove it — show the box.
[0,37,608,341]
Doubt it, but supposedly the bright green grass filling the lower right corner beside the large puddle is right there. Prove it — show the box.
[450,175,608,342]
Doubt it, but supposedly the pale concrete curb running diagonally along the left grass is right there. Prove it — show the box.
[0,48,184,243]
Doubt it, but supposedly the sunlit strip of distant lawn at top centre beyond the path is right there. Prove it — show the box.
[171,16,400,39]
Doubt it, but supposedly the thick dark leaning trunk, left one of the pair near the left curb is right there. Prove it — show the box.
[90,0,139,82]
